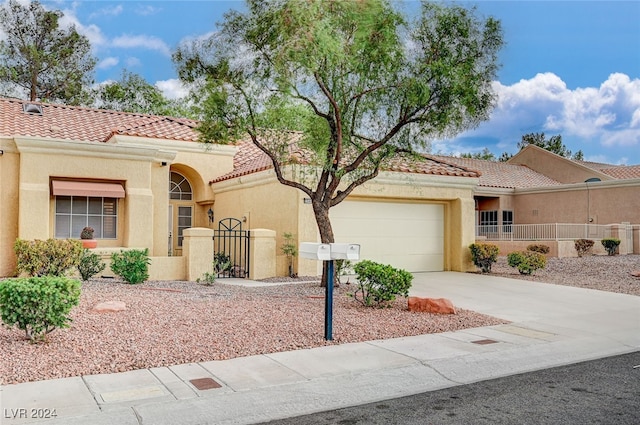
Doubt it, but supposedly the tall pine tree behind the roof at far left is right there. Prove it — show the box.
[0,0,96,105]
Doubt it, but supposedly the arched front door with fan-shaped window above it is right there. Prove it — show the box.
[169,171,194,255]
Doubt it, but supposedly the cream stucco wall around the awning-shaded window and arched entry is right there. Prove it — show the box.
[0,136,237,276]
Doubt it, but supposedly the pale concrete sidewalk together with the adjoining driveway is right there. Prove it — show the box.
[0,272,640,425]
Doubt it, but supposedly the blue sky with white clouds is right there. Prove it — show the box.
[5,0,640,165]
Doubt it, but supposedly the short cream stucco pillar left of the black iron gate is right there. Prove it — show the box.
[182,227,213,281]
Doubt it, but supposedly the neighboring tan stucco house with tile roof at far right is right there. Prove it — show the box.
[436,145,640,252]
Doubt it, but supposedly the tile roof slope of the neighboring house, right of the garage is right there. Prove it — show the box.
[428,155,562,189]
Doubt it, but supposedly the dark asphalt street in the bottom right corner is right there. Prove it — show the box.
[268,351,640,425]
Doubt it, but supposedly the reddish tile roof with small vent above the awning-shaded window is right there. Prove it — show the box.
[0,98,198,142]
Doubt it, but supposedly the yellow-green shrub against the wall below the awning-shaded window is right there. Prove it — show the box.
[13,239,83,276]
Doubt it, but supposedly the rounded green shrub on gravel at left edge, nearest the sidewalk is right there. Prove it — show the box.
[0,276,80,342]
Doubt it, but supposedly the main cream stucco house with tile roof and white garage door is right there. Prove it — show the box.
[0,98,479,279]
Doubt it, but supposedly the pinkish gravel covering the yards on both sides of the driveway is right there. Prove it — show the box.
[0,256,640,384]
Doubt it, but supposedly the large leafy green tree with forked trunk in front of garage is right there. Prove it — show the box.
[173,0,503,252]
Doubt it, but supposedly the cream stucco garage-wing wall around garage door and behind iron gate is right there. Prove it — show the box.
[213,171,477,276]
